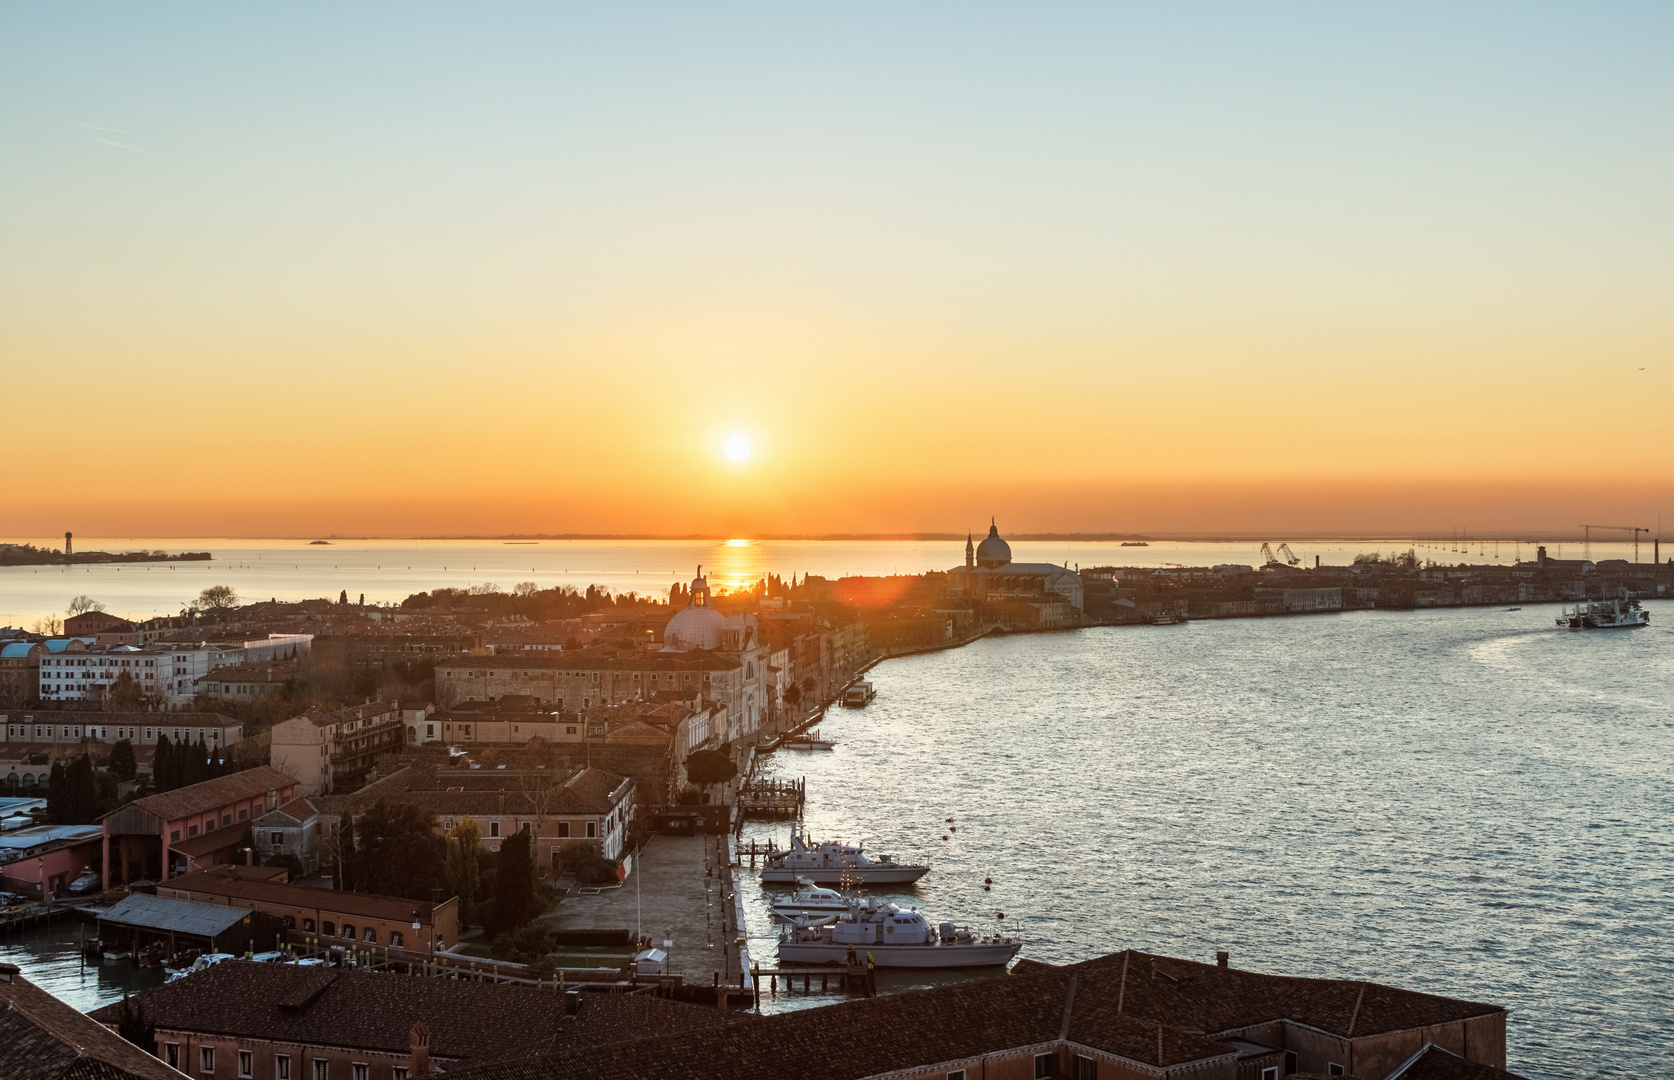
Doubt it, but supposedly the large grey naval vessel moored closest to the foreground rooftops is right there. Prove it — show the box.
[778,899,1023,968]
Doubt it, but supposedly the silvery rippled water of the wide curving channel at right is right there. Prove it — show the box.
[745,603,1674,1077]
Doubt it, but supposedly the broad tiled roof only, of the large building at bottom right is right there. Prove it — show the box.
[438,951,1507,1080]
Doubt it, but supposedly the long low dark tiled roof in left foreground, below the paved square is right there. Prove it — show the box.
[90,961,733,1062]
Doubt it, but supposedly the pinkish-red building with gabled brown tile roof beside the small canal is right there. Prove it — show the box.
[102,765,296,887]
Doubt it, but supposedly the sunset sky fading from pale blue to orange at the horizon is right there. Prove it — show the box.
[0,2,1674,539]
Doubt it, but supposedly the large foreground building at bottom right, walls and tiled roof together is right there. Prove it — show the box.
[435,951,1533,1080]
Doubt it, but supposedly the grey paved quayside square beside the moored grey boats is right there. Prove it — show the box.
[547,836,733,986]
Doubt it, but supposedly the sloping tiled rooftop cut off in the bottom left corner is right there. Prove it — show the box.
[0,964,182,1080]
